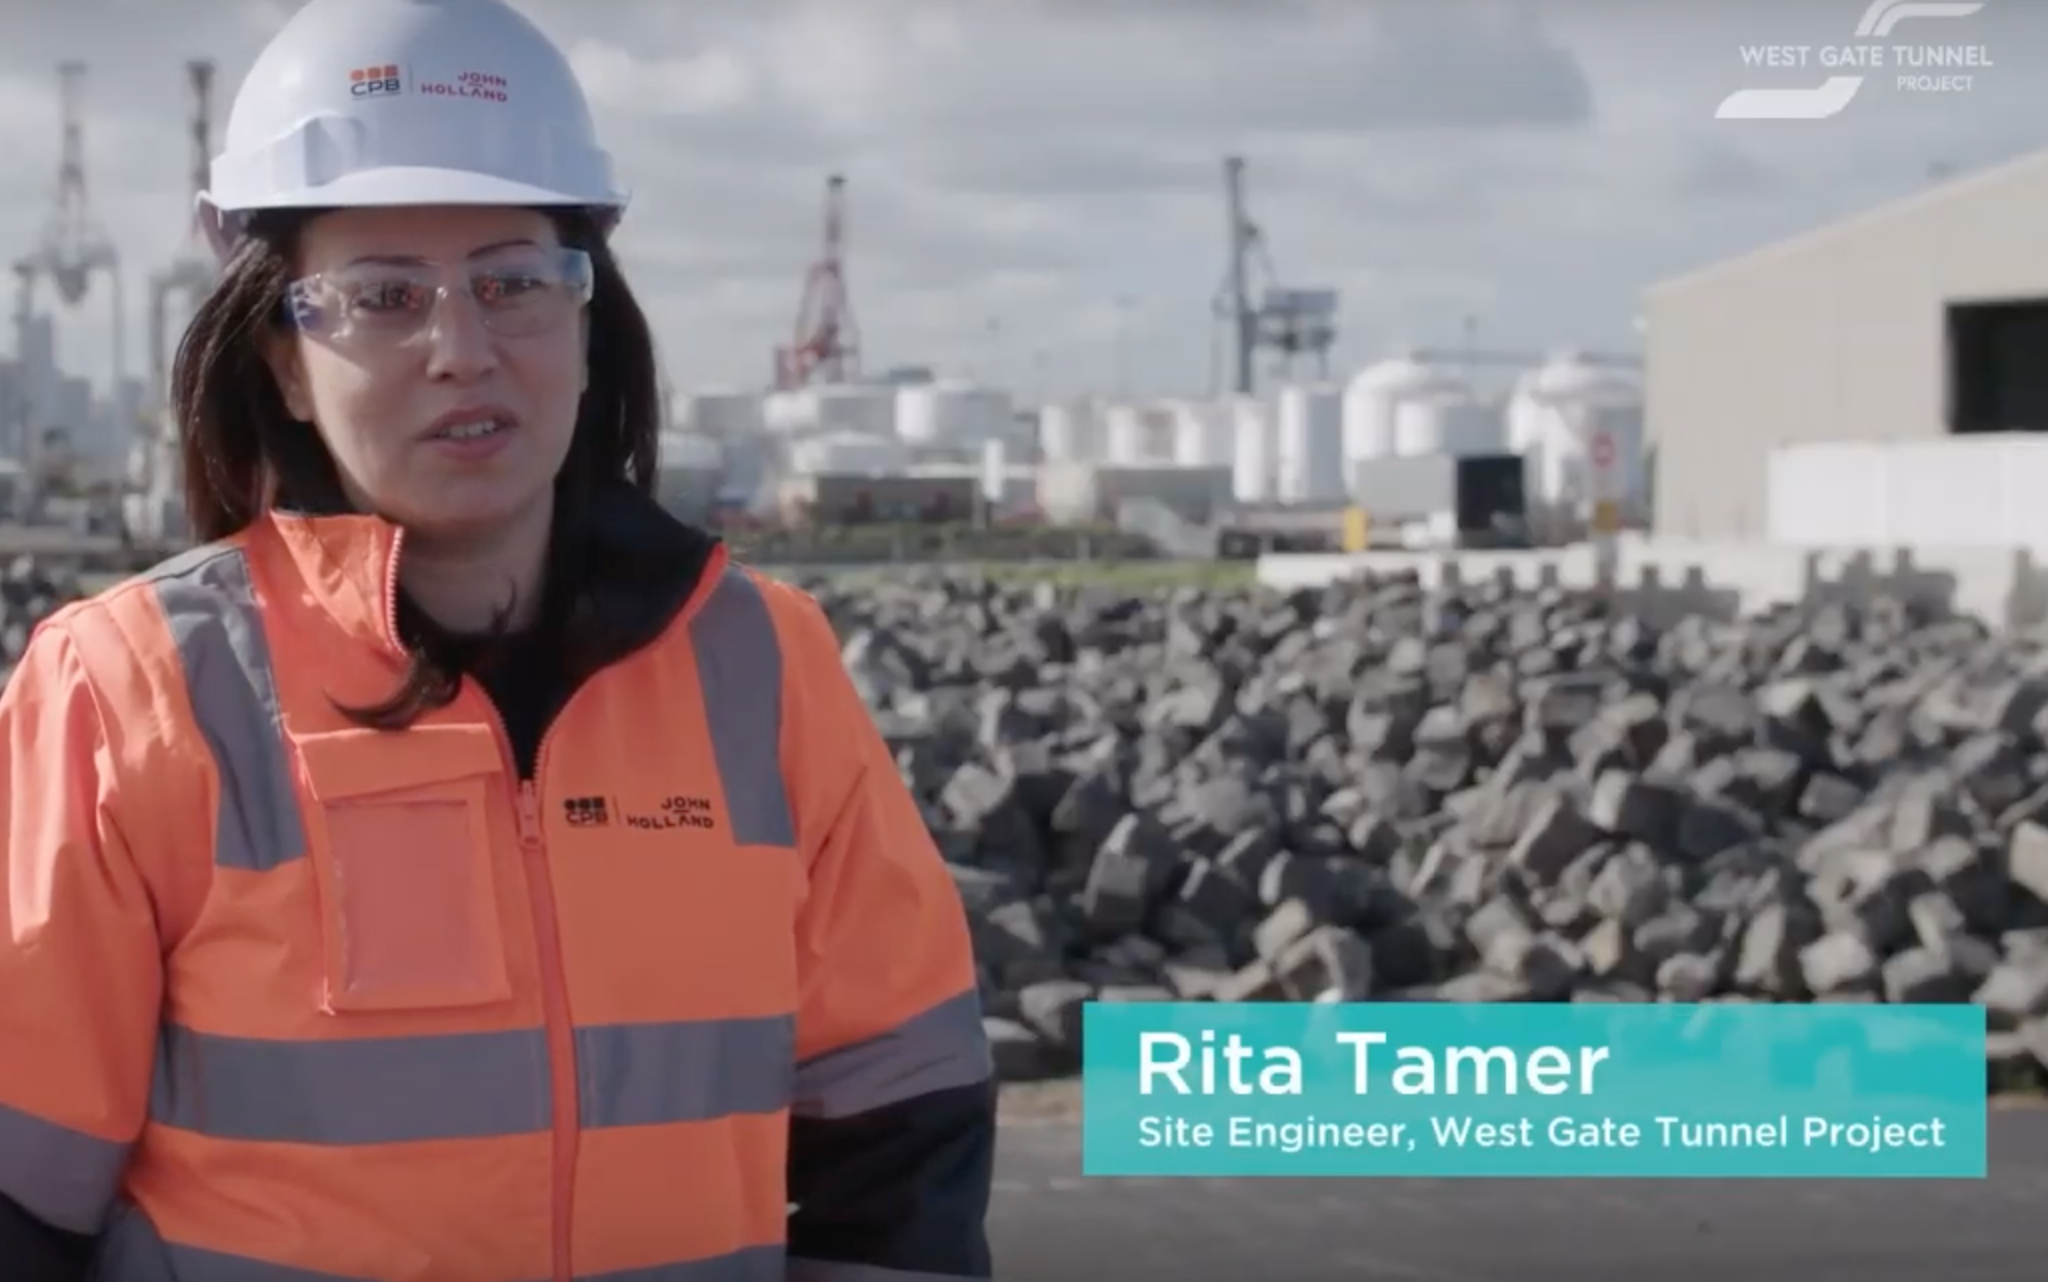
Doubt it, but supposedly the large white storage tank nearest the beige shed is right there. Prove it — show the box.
[1507,352,1647,510]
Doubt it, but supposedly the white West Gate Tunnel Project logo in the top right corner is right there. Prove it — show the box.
[1714,0,1993,121]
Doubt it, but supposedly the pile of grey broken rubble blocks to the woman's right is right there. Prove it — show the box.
[811,578,2048,1085]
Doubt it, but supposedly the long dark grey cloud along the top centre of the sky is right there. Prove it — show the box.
[770,0,1593,137]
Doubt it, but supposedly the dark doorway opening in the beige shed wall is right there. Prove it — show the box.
[1948,299,2048,434]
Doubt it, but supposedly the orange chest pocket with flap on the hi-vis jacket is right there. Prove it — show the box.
[295,725,512,1014]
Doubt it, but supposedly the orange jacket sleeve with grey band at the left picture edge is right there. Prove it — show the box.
[0,623,162,1235]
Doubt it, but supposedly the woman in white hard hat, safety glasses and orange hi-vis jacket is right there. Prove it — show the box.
[0,0,993,1282]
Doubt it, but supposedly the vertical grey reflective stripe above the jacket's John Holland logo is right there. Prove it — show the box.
[690,565,797,846]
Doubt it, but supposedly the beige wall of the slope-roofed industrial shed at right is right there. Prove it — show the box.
[1645,152,2048,541]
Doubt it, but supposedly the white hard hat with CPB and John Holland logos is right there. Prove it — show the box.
[199,0,627,256]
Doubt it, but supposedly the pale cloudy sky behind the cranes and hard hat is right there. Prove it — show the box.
[0,0,2048,395]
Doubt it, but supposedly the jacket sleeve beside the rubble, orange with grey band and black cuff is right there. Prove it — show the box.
[770,588,995,1282]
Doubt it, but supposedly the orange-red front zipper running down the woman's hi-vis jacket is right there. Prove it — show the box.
[479,690,582,1282]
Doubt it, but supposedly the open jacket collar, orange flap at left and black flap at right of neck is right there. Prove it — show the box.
[264,483,725,653]
